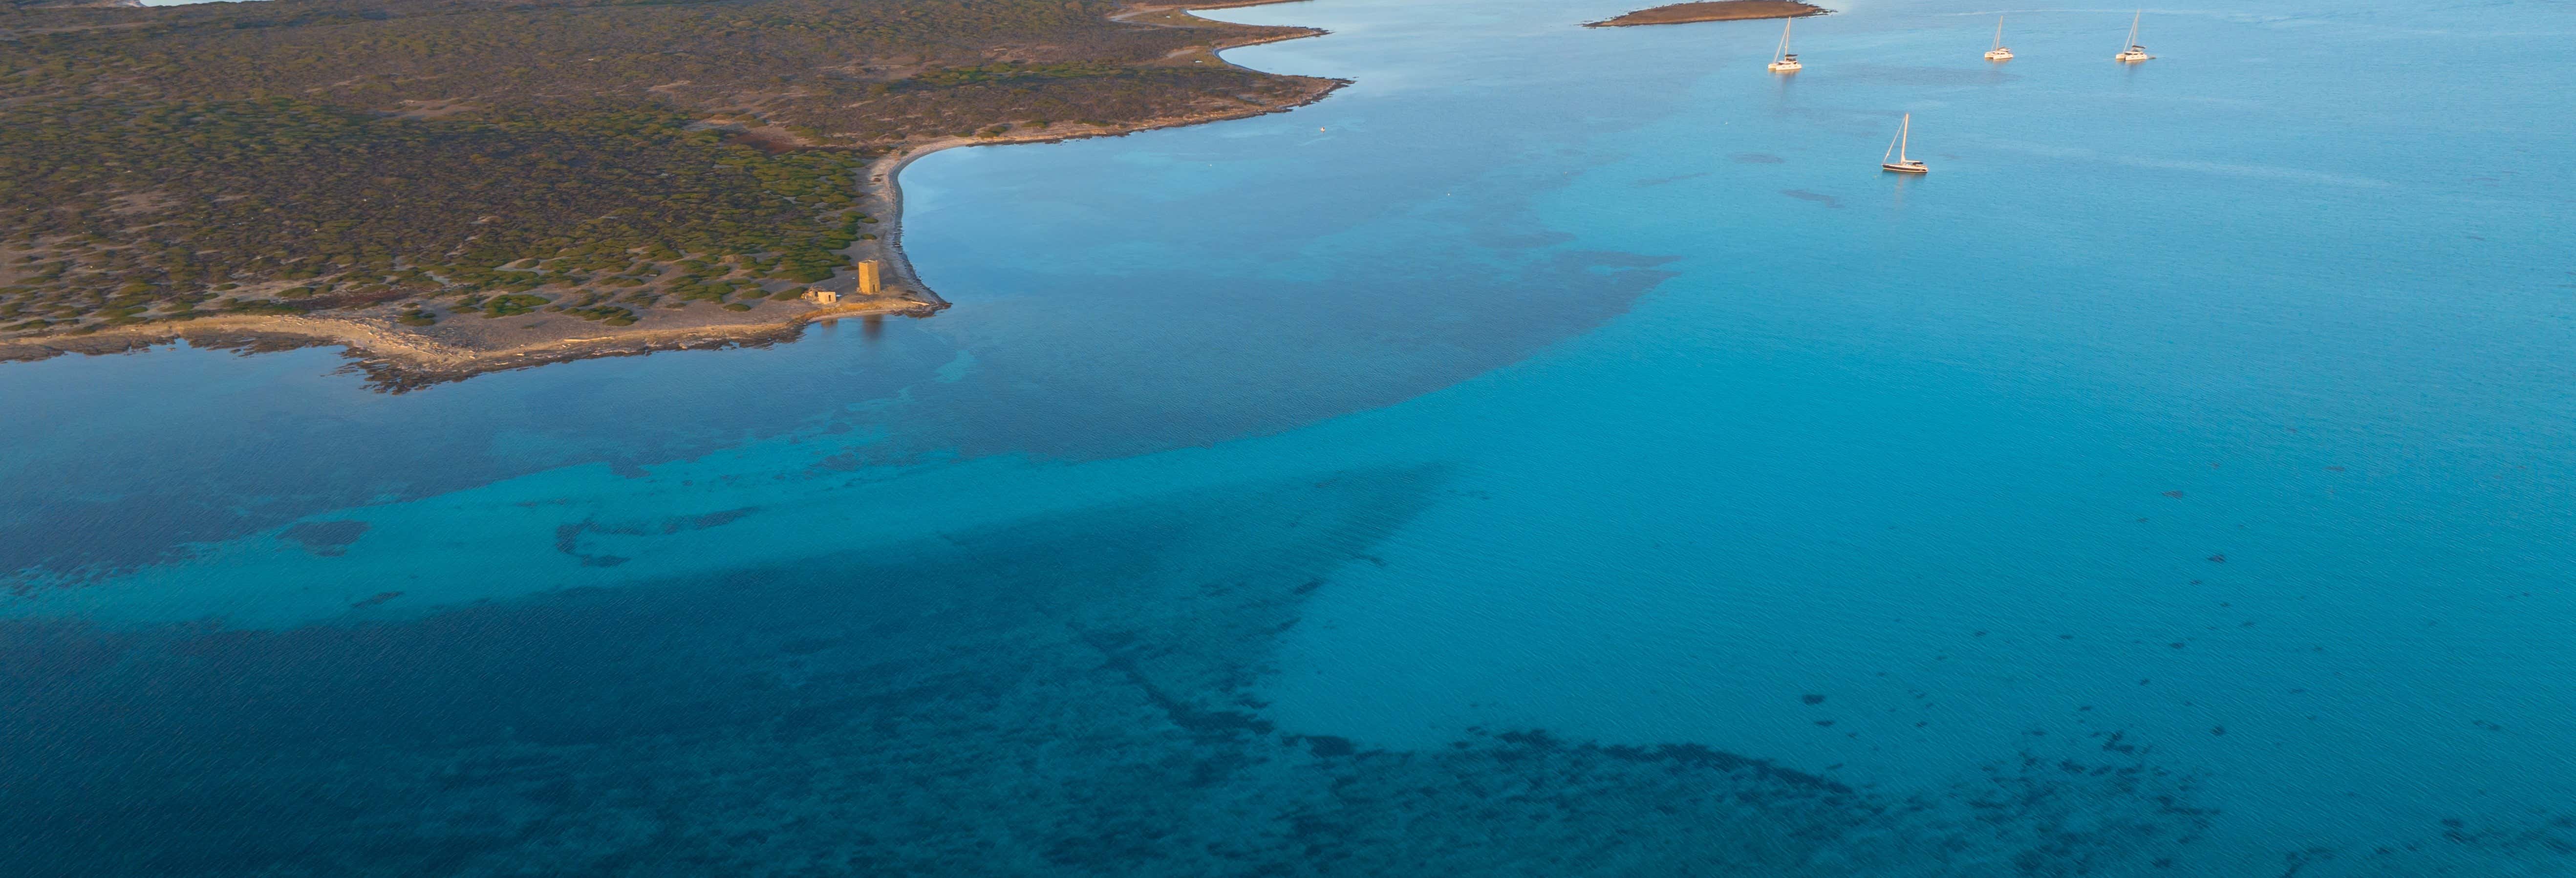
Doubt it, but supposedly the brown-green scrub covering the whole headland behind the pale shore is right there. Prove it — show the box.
[0,0,1324,332]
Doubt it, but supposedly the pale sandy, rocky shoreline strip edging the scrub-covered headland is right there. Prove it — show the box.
[0,0,1350,394]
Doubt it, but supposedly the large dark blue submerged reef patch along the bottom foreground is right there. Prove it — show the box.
[0,469,2566,876]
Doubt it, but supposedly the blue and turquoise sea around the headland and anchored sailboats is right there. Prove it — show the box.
[0,0,2576,878]
